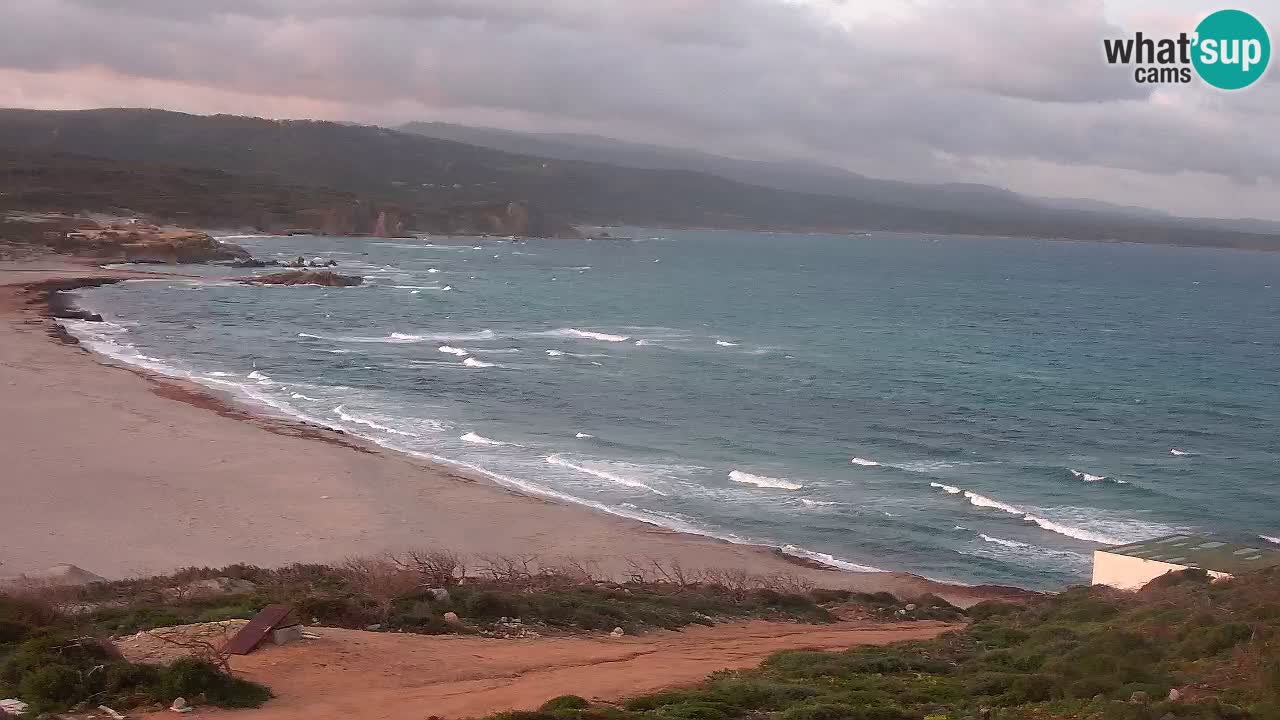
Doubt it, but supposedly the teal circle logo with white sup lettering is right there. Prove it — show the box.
[1192,10,1271,90]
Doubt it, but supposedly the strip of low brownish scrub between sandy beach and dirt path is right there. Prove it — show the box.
[22,552,849,635]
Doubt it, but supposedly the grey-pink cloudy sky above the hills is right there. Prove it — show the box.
[0,0,1280,219]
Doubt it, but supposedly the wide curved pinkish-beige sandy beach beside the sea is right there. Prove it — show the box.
[0,258,1027,605]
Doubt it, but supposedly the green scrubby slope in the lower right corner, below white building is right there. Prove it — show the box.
[481,569,1280,720]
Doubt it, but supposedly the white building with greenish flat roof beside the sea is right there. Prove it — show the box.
[1093,536,1280,591]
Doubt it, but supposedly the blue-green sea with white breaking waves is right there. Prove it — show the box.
[60,228,1280,591]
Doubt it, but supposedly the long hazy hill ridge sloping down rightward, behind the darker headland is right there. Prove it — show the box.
[0,109,1280,249]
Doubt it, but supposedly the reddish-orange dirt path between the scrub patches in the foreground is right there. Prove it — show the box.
[152,621,952,720]
